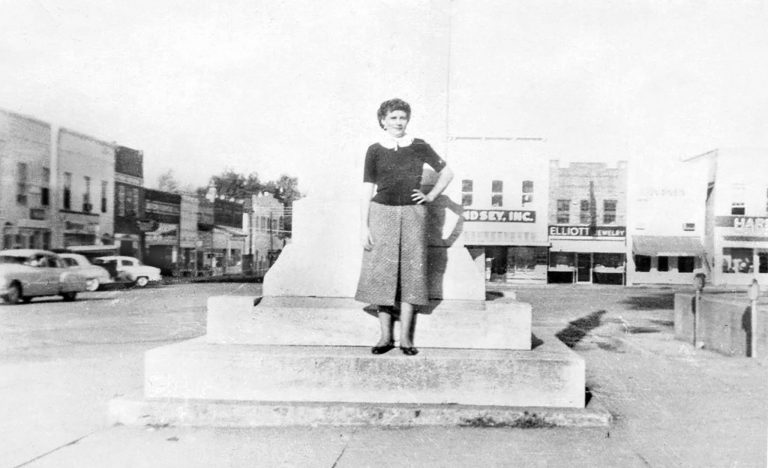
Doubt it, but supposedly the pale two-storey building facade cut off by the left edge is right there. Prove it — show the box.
[0,110,54,249]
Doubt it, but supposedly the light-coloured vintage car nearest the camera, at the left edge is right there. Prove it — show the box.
[0,249,86,304]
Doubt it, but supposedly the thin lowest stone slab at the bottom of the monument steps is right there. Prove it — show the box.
[108,395,611,428]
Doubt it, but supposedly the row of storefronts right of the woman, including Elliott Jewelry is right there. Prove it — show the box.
[450,138,768,286]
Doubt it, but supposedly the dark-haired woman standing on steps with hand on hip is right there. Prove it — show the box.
[355,99,453,356]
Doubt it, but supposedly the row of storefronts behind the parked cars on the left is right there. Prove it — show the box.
[0,110,286,276]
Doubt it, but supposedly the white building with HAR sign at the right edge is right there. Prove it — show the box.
[686,149,768,286]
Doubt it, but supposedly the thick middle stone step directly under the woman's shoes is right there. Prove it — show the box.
[144,337,585,408]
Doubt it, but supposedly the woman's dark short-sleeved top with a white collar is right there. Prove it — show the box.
[363,138,445,205]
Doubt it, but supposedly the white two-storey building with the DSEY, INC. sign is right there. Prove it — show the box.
[449,137,549,283]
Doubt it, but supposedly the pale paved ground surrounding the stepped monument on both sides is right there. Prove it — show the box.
[0,284,768,467]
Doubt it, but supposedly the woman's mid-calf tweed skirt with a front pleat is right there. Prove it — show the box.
[355,202,429,306]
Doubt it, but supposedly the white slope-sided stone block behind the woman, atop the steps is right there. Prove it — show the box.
[263,188,485,300]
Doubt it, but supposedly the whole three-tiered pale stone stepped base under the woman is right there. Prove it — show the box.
[110,297,610,426]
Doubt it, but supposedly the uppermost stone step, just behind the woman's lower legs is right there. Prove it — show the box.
[206,296,531,350]
